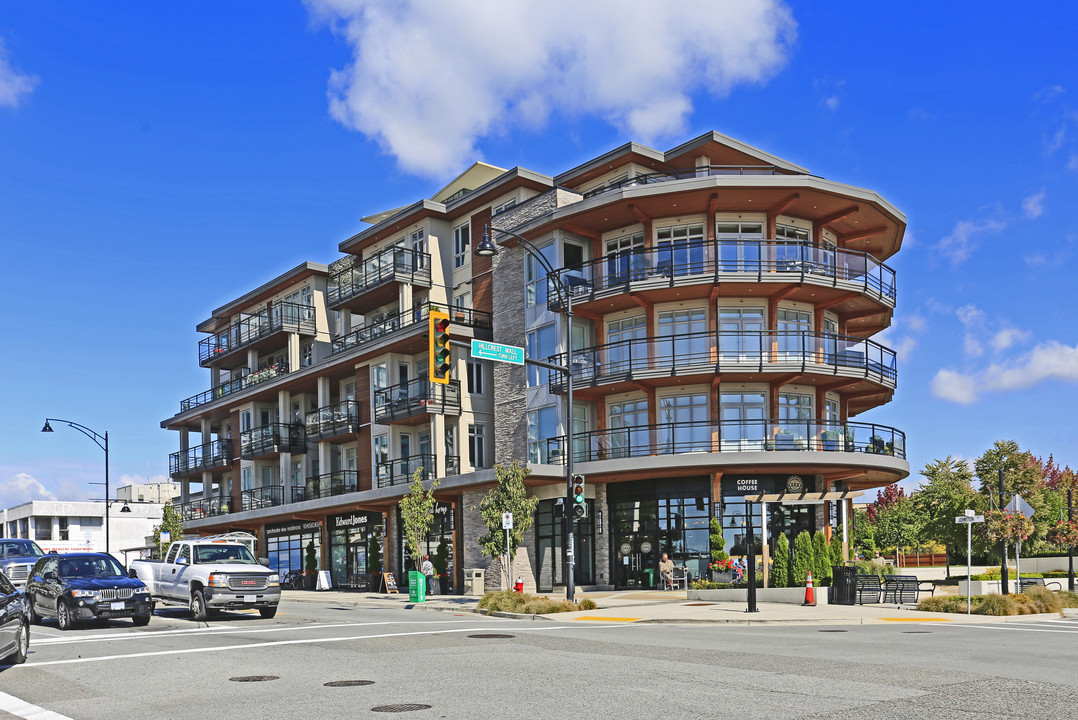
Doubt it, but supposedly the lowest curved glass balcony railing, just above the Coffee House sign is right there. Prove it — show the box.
[547,419,906,462]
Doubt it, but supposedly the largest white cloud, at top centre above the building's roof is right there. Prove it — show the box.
[306,0,797,176]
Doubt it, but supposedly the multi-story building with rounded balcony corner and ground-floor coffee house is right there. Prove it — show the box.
[163,133,909,591]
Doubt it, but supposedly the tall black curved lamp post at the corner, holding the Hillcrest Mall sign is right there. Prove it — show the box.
[475,223,577,603]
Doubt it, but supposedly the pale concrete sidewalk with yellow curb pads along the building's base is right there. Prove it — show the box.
[273,591,1078,625]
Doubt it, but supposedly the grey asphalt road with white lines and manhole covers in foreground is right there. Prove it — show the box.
[0,601,1078,720]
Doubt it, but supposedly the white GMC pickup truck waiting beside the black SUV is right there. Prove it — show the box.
[129,537,280,620]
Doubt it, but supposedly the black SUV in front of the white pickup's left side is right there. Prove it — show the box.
[26,553,153,629]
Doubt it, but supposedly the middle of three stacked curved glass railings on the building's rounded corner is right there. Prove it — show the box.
[549,331,898,392]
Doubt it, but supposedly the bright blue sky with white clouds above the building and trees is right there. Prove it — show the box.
[0,0,1078,507]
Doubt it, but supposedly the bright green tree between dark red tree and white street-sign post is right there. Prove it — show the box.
[913,455,983,578]
